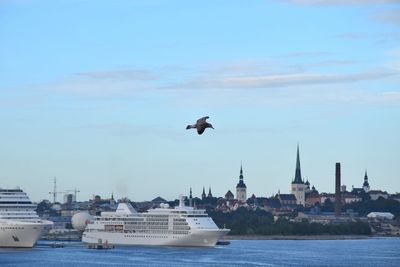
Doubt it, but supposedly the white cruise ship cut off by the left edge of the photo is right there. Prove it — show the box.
[0,188,53,248]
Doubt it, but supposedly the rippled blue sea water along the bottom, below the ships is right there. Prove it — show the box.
[0,238,400,267]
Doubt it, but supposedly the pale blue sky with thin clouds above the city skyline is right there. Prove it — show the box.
[0,0,400,201]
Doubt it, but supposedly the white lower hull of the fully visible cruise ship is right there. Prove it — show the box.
[82,229,229,247]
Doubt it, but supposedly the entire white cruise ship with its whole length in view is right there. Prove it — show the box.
[82,198,229,247]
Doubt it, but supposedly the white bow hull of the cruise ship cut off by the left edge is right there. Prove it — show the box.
[0,220,52,248]
